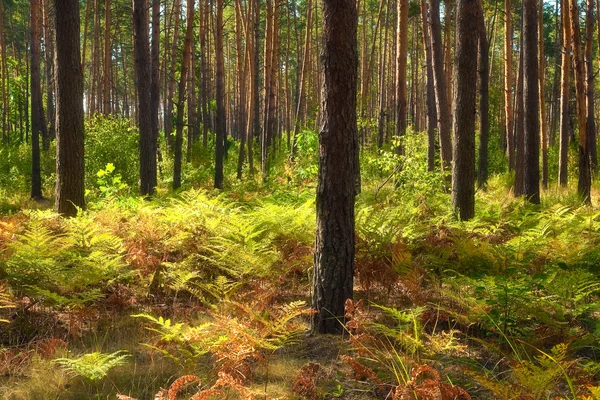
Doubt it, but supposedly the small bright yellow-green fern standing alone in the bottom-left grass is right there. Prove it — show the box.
[54,351,130,381]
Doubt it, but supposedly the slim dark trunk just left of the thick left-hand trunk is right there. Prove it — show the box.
[29,0,44,200]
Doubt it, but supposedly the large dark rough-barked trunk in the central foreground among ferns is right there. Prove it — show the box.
[312,0,358,333]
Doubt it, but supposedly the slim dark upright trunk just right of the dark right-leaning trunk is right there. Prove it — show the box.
[215,0,226,189]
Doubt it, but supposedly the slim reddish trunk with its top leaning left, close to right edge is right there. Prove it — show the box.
[569,0,592,204]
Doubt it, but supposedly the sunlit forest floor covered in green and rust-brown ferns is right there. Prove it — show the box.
[0,172,600,400]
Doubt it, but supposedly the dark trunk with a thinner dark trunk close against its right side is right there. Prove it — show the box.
[133,0,156,195]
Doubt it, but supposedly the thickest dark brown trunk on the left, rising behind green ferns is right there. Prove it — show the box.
[54,0,85,216]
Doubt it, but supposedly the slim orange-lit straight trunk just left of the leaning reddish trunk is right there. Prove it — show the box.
[558,0,571,187]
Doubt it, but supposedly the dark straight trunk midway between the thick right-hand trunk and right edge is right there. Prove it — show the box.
[523,0,540,204]
